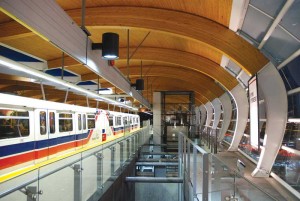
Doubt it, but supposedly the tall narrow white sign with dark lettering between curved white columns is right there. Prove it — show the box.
[248,75,260,149]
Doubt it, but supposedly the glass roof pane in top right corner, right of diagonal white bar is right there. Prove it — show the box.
[280,0,300,39]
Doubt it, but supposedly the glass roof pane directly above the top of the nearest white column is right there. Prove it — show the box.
[263,26,300,63]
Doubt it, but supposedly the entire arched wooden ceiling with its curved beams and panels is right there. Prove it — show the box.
[0,0,268,108]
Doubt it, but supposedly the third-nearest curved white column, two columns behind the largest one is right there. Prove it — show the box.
[218,93,232,141]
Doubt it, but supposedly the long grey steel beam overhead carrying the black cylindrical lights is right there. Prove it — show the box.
[0,0,150,107]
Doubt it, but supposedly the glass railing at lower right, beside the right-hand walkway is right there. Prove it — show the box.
[178,133,276,201]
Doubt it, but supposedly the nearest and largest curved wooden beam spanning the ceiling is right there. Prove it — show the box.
[66,6,268,75]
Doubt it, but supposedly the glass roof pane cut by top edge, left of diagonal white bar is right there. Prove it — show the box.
[250,0,285,17]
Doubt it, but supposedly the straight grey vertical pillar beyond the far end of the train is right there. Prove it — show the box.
[153,92,161,144]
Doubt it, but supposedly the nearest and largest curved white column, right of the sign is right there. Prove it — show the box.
[252,62,288,177]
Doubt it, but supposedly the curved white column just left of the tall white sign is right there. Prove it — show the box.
[228,85,249,151]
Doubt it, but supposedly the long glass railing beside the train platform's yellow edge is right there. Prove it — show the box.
[0,126,150,201]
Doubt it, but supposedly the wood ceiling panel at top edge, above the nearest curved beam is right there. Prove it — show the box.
[56,0,232,27]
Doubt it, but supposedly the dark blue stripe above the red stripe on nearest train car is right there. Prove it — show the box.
[0,132,89,157]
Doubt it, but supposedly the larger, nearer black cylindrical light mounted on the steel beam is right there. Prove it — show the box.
[102,32,119,60]
